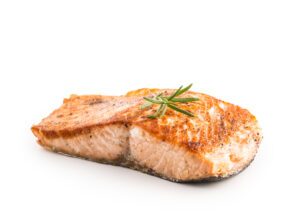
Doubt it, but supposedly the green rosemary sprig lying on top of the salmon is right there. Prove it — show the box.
[141,84,199,119]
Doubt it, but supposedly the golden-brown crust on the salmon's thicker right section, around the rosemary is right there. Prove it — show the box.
[124,89,261,152]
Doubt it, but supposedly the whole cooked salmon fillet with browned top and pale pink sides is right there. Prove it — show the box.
[32,89,262,182]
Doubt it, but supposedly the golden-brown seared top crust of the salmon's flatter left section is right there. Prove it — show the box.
[31,95,141,138]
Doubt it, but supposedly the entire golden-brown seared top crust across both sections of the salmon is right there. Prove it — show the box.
[32,89,261,152]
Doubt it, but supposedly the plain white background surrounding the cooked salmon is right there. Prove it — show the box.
[0,0,300,224]
